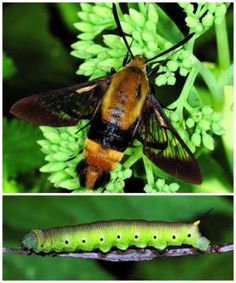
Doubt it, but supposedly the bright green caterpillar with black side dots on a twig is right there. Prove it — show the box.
[21,220,210,253]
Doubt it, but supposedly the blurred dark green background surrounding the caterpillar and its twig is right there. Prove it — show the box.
[3,196,233,280]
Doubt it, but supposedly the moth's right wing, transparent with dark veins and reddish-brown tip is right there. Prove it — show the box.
[137,94,202,184]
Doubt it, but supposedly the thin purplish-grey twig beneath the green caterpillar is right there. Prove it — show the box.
[3,244,234,262]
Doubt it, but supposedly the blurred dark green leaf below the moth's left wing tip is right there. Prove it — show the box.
[3,118,49,193]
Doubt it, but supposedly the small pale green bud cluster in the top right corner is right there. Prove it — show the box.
[179,2,228,34]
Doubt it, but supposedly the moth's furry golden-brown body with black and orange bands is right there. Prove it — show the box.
[77,56,149,189]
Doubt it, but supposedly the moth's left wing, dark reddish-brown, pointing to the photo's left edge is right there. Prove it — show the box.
[10,76,111,127]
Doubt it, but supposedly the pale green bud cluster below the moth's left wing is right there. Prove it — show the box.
[38,120,87,190]
